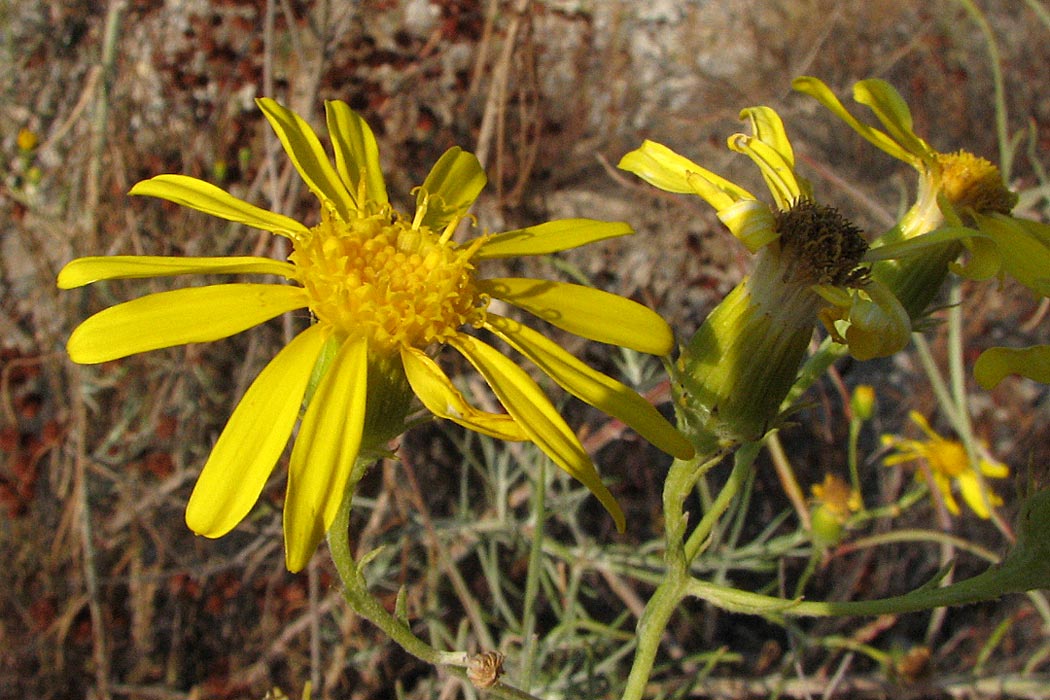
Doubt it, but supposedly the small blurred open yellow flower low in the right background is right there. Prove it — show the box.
[882,411,1010,519]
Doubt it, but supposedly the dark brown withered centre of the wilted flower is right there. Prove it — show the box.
[774,199,867,287]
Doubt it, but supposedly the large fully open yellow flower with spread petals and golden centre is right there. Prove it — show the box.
[58,99,693,571]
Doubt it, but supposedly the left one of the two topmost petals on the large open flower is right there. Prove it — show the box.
[255,98,357,221]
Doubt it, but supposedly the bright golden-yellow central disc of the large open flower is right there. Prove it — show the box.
[289,206,488,353]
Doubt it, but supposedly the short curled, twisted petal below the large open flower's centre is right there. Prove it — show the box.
[401,346,528,442]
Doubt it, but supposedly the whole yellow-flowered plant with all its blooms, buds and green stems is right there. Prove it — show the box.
[58,78,1050,700]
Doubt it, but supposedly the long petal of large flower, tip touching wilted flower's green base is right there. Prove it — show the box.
[485,314,694,460]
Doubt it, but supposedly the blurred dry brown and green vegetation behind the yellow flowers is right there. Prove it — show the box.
[0,0,1050,700]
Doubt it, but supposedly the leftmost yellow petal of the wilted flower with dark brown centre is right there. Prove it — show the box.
[617,139,755,211]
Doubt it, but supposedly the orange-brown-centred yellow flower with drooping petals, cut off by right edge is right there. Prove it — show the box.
[793,77,1050,388]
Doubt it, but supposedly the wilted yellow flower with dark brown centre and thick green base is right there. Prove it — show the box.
[620,107,910,449]
